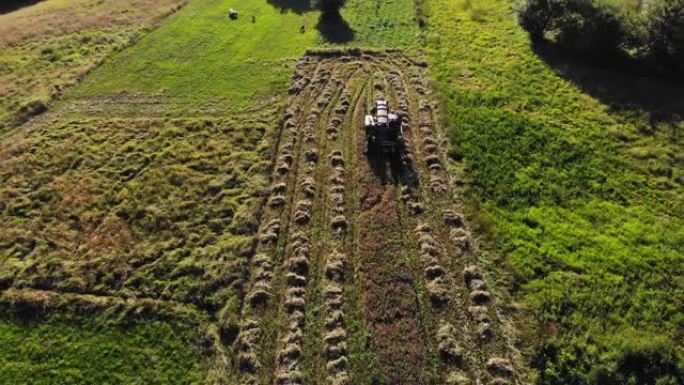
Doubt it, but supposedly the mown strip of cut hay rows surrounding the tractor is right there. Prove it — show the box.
[235,53,517,384]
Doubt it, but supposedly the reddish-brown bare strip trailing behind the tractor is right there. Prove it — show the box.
[356,54,425,384]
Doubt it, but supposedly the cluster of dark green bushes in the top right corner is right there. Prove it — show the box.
[518,0,684,74]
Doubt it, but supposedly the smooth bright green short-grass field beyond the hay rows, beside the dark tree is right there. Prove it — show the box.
[73,0,419,116]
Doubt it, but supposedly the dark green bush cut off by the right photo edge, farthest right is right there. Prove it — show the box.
[648,0,684,72]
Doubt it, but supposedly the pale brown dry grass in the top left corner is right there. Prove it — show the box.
[0,0,185,46]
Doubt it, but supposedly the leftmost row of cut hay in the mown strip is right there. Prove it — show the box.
[234,56,327,383]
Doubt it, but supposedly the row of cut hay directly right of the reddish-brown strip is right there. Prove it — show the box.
[376,61,479,384]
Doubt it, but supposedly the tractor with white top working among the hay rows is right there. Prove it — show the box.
[365,99,401,161]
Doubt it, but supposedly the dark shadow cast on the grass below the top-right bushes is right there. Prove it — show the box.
[533,41,684,124]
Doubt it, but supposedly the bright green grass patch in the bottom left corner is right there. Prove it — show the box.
[0,315,206,385]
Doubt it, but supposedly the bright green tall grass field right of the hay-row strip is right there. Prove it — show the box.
[426,0,684,384]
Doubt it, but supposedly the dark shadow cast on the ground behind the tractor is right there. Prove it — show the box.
[367,140,420,188]
